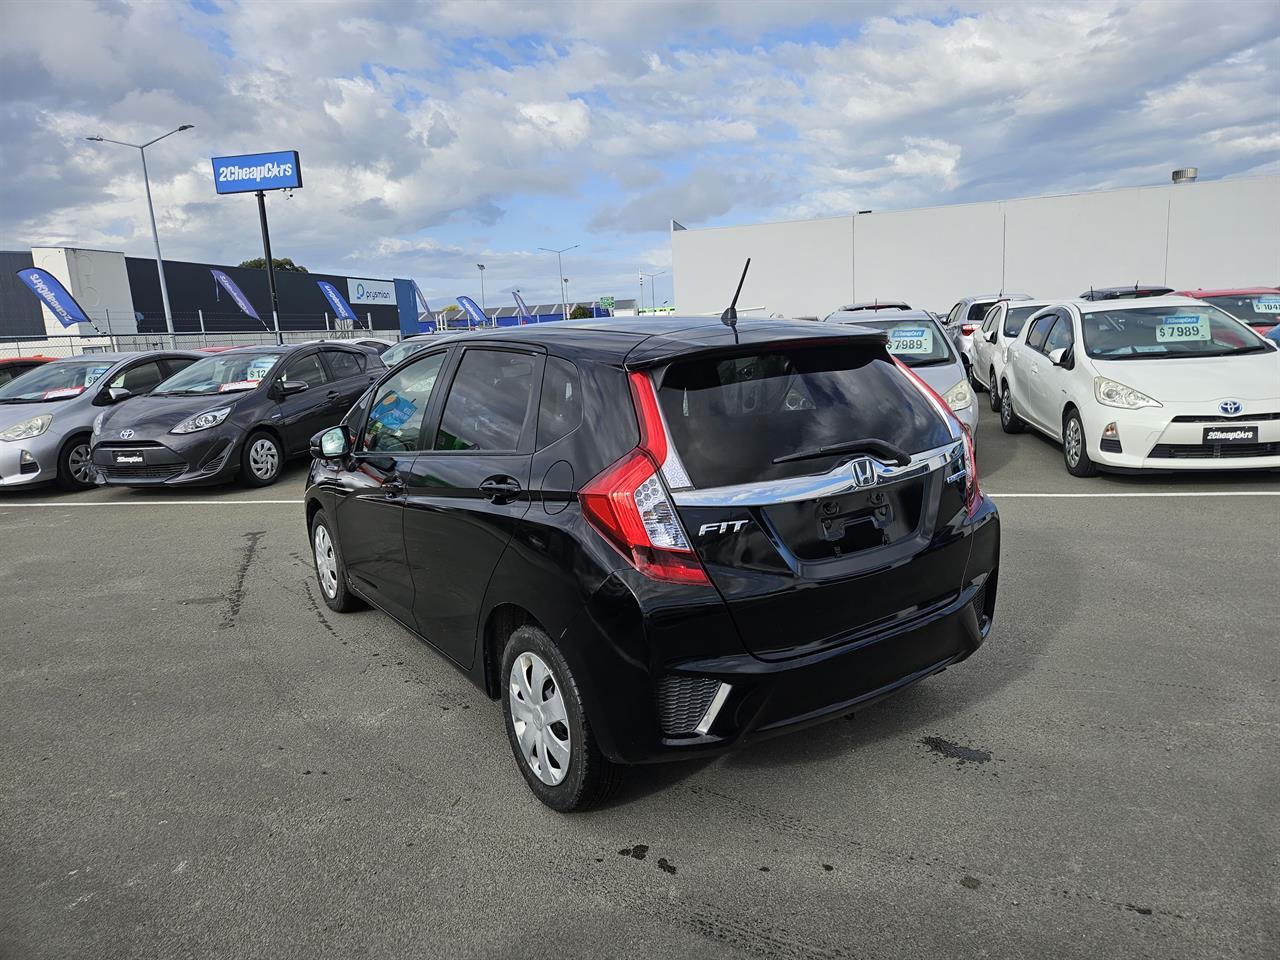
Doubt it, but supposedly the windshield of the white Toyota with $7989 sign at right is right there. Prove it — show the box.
[1080,303,1267,360]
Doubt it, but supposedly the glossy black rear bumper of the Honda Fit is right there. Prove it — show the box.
[584,500,1000,763]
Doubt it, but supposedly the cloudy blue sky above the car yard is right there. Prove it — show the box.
[0,0,1280,306]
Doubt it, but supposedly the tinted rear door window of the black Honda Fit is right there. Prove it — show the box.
[435,349,536,452]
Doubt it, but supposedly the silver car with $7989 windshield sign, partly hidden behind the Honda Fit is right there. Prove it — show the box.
[827,310,978,435]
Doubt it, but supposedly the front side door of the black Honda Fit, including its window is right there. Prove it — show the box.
[337,349,448,628]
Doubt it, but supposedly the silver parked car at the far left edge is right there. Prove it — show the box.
[0,351,200,490]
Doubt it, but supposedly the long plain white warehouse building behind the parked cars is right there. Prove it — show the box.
[671,175,1280,317]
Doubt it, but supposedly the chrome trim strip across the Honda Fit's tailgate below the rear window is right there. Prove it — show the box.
[671,440,964,507]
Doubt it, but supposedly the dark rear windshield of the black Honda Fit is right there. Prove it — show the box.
[658,343,951,488]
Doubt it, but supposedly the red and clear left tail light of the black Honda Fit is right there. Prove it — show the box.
[577,372,710,584]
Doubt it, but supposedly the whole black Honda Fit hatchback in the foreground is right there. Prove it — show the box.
[306,319,1000,810]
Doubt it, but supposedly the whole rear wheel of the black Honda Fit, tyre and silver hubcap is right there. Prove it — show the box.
[499,626,621,813]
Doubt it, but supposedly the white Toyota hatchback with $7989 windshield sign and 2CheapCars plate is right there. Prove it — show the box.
[1000,297,1280,476]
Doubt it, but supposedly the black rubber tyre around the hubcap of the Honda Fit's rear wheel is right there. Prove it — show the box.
[499,626,622,813]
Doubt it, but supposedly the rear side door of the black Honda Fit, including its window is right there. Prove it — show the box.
[404,346,543,667]
